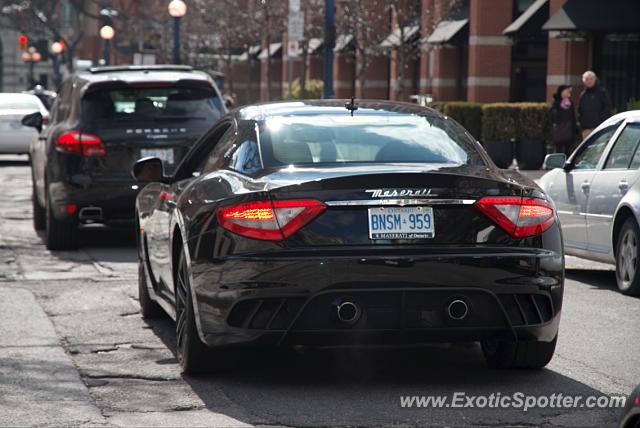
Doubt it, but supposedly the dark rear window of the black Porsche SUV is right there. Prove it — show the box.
[82,87,223,126]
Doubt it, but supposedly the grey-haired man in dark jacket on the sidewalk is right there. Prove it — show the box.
[578,71,613,138]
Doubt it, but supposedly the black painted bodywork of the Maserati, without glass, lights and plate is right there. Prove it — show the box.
[136,101,564,346]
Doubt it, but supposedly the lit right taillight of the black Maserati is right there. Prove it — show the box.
[475,196,554,238]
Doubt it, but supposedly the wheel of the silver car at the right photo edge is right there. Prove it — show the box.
[616,218,640,296]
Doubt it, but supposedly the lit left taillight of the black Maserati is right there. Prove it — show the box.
[218,199,327,241]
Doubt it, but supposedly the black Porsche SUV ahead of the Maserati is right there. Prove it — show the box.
[25,66,225,250]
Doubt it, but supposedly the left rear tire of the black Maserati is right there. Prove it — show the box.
[175,247,221,374]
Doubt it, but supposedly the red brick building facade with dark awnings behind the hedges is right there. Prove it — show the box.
[227,0,640,111]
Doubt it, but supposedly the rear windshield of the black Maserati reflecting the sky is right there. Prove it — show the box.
[260,112,483,166]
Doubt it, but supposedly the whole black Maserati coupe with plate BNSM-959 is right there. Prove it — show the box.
[134,101,564,372]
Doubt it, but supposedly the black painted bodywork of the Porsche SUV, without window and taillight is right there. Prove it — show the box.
[30,67,222,226]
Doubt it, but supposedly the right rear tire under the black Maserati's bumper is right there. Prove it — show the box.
[482,335,558,369]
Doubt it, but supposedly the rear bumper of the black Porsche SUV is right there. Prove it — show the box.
[49,180,138,226]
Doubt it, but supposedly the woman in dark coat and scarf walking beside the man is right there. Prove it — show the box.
[551,85,578,156]
